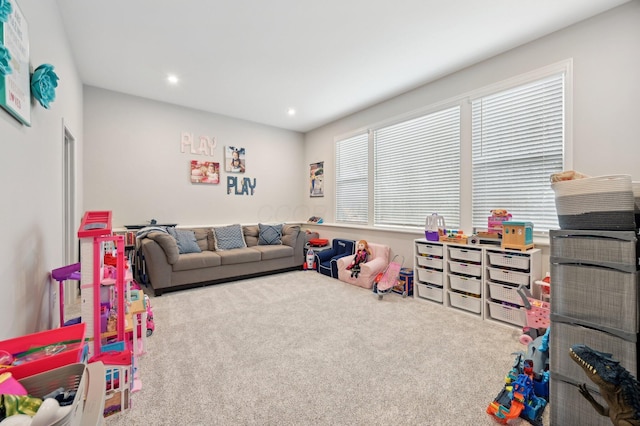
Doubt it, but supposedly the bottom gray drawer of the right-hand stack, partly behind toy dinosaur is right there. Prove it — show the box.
[549,376,611,426]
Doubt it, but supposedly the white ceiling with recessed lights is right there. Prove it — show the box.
[57,0,629,132]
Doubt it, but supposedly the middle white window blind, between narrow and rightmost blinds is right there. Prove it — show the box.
[373,106,460,227]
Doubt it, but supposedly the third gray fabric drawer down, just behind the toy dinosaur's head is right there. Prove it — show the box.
[549,318,638,383]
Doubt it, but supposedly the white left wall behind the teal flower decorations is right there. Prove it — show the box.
[0,0,82,340]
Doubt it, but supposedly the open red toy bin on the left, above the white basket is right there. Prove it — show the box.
[0,323,85,380]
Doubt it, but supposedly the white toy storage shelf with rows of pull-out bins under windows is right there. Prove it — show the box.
[414,238,542,327]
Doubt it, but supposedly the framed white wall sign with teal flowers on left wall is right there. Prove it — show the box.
[0,0,31,126]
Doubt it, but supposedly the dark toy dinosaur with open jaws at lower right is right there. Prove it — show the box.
[569,345,640,426]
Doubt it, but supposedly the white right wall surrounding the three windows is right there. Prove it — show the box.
[305,1,640,268]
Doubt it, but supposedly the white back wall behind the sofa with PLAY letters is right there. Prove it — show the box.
[84,87,309,227]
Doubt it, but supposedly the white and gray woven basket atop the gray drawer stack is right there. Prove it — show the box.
[551,175,636,231]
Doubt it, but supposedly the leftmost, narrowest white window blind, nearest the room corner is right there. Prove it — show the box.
[336,133,369,224]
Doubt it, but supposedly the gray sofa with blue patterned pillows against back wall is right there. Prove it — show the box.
[138,224,304,296]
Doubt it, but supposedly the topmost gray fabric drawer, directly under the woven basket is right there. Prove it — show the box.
[549,230,640,272]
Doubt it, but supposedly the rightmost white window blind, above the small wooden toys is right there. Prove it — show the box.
[472,73,564,232]
